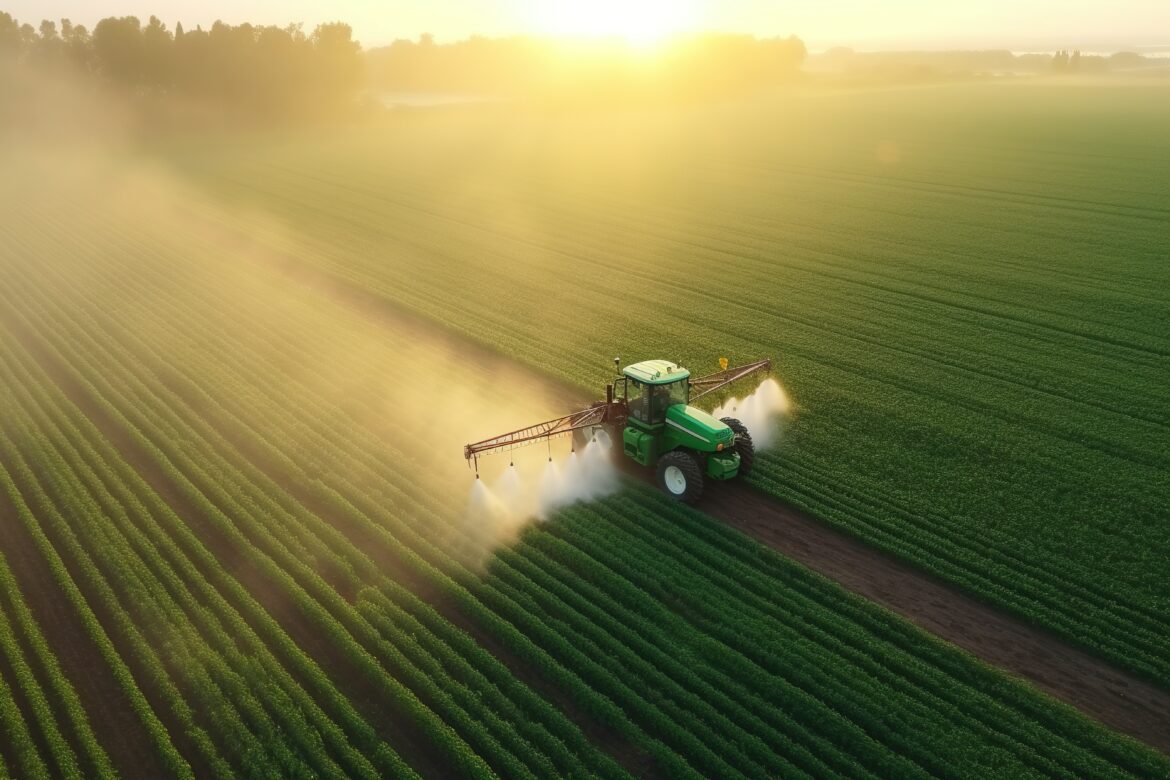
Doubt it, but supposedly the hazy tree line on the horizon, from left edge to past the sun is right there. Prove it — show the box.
[0,12,806,117]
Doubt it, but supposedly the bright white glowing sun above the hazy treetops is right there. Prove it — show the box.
[532,0,697,47]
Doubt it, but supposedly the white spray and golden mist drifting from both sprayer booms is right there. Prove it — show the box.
[0,70,785,565]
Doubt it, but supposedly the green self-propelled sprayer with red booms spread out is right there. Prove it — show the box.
[463,358,772,503]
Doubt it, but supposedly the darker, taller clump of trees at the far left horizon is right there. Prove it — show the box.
[0,12,365,115]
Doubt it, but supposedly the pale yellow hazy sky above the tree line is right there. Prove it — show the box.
[9,0,1170,50]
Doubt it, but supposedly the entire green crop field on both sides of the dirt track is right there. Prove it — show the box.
[0,84,1170,778]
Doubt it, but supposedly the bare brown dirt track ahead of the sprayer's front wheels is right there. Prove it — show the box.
[700,483,1170,753]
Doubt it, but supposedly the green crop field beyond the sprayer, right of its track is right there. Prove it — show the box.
[162,84,1170,684]
